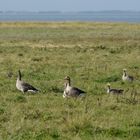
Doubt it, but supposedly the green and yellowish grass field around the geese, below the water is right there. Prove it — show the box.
[0,22,140,140]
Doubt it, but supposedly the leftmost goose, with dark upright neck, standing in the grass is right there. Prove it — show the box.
[16,70,38,93]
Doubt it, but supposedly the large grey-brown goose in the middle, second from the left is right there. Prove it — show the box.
[63,76,85,98]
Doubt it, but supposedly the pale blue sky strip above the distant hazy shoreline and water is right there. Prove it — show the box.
[0,0,140,11]
